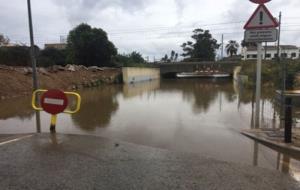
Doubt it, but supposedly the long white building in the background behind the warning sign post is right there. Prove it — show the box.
[241,45,300,60]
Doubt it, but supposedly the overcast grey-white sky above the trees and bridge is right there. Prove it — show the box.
[0,0,300,60]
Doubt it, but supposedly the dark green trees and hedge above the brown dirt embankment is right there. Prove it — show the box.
[0,24,146,67]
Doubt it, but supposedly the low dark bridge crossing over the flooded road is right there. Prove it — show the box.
[155,61,240,75]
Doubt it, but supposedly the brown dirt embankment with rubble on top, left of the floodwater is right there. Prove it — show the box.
[0,65,121,99]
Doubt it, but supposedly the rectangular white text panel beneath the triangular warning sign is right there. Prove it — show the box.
[244,28,278,42]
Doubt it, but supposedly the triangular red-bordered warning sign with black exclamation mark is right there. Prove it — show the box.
[244,4,279,30]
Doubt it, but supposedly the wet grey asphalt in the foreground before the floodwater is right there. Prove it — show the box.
[0,134,299,190]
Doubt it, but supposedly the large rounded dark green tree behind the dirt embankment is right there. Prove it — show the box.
[67,24,117,66]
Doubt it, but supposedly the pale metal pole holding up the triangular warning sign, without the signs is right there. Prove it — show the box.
[255,42,262,128]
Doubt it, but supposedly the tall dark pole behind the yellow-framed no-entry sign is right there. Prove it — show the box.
[27,0,41,133]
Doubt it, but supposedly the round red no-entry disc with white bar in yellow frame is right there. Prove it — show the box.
[41,89,68,115]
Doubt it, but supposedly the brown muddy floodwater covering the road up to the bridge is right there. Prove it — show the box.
[0,79,300,181]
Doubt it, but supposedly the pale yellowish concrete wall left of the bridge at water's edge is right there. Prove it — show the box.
[122,67,160,84]
